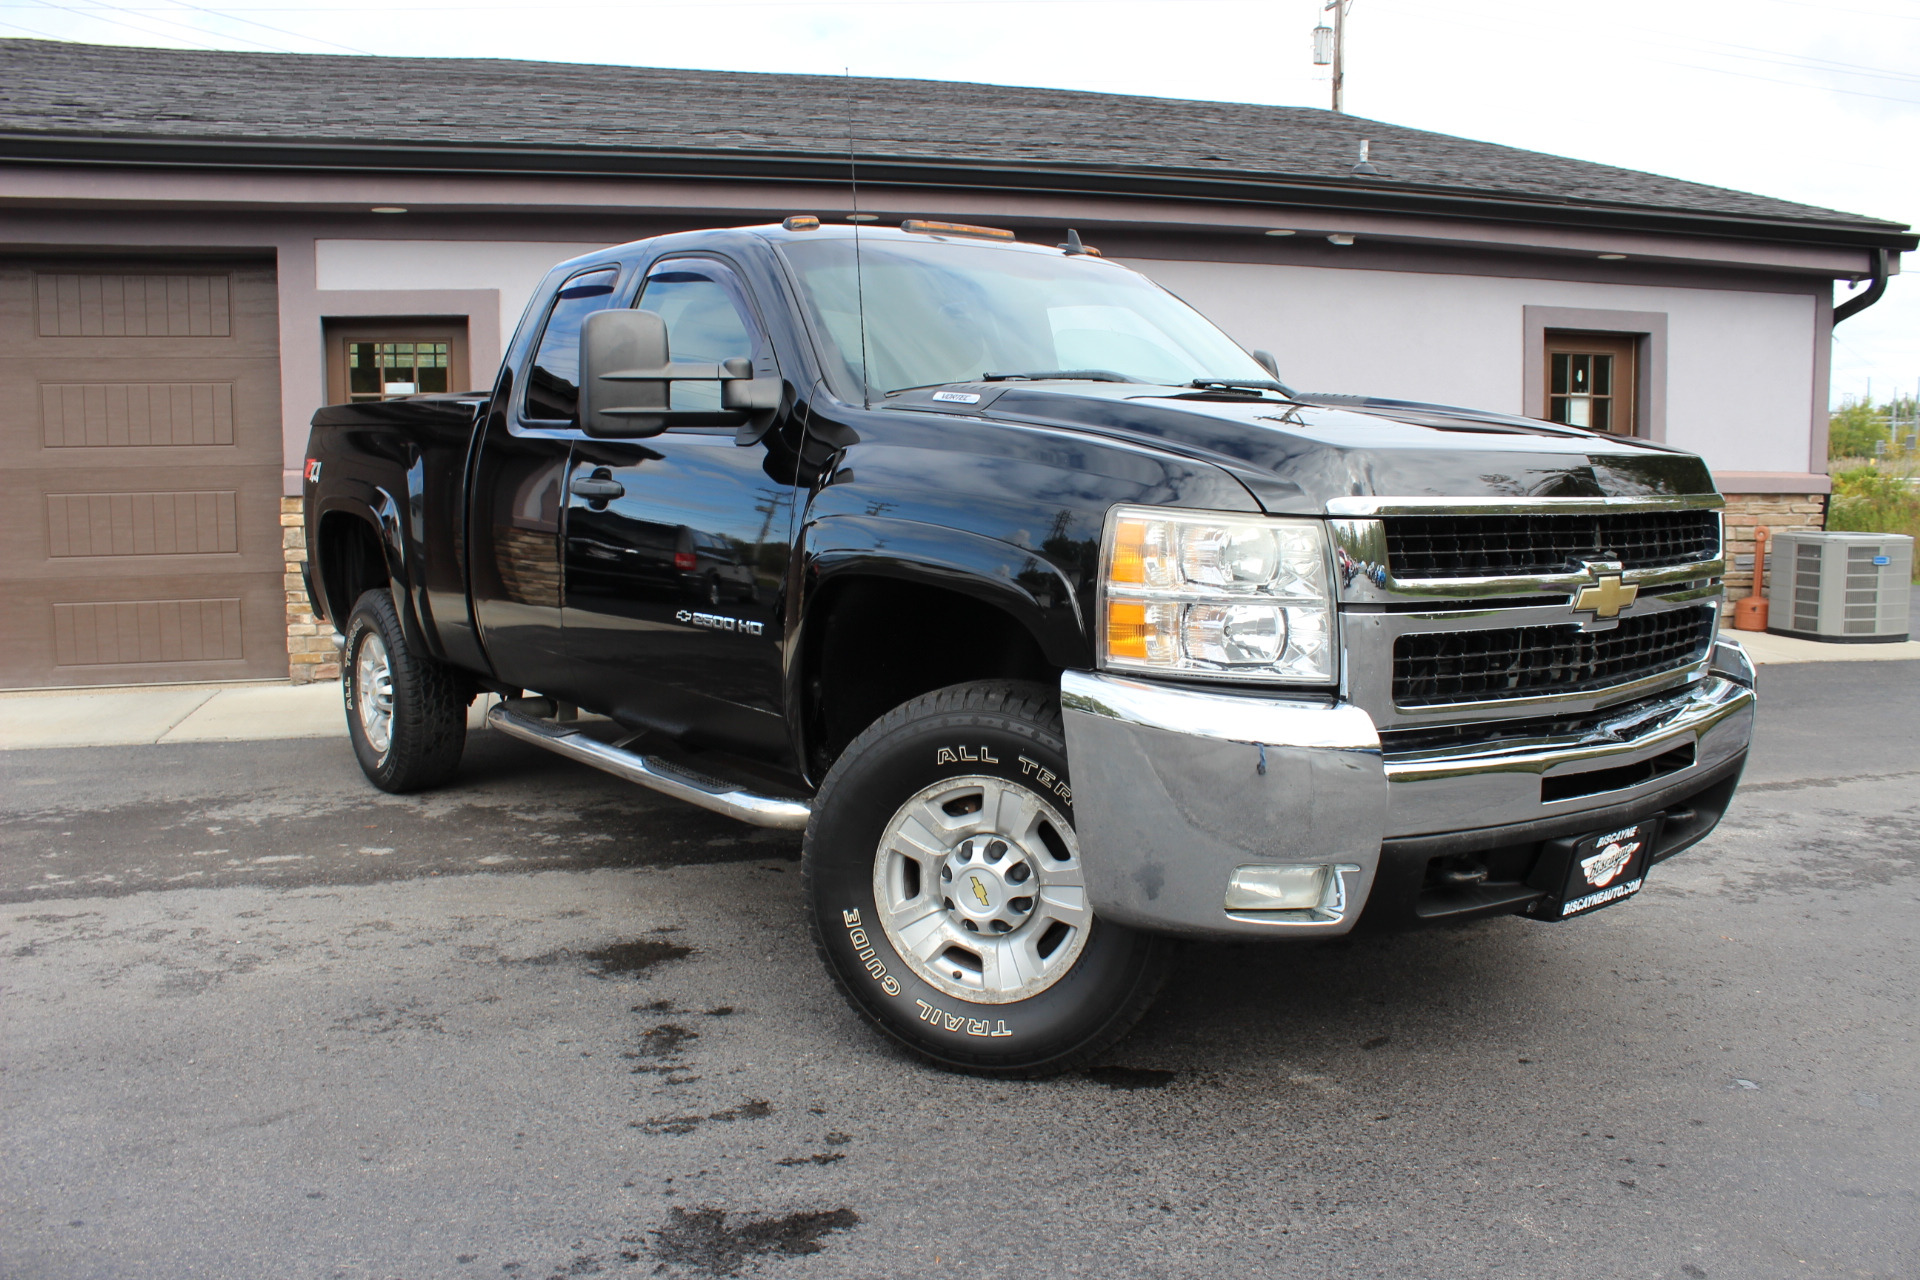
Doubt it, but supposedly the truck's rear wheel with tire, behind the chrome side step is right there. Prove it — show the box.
[340,589,472,793]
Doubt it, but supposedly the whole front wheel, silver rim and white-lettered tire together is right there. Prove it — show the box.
[804,681,1167,1077]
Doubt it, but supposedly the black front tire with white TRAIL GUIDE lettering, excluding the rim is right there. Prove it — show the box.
[804,681,1165,1077]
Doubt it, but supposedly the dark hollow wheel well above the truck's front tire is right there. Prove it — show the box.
[797,572,1062,783]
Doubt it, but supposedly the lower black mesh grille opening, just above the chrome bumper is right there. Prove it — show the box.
[1394,606,1713,706]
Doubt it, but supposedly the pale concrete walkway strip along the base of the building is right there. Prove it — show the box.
[0,631,1920,750]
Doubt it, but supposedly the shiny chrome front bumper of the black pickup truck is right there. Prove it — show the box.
[1060,641,1753,936]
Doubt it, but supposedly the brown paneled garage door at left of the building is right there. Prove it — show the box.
[0,259,286,689]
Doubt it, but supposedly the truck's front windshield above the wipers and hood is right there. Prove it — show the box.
[781,236,1271,399]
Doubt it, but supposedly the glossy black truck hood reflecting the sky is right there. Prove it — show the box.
[887,382,1715,514]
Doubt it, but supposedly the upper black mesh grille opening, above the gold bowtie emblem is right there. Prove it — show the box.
[1386,510,1720,580]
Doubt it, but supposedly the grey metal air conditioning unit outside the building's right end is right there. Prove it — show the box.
[1766,532,1914,645]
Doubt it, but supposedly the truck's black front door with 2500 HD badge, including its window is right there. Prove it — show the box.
[564,257,795,758]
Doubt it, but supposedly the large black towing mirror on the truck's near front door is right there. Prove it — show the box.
[580,311,778,439]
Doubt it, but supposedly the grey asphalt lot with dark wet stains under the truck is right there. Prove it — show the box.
[0,662,1920,1280]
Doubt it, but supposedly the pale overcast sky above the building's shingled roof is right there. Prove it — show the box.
[0,0,1920,403]
